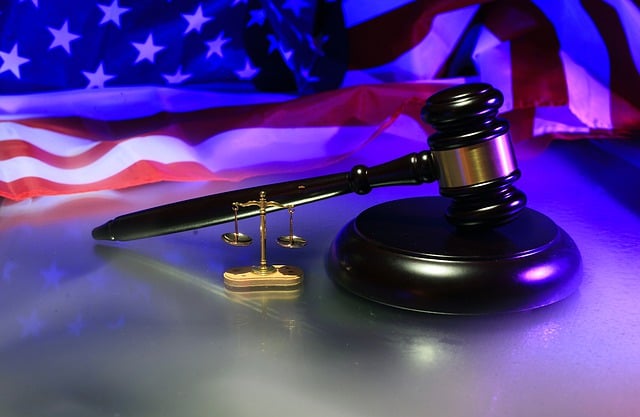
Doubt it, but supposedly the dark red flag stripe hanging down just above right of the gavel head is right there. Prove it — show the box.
[480,0,569,108]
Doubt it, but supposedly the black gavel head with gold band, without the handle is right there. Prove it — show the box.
[421,83,526,228]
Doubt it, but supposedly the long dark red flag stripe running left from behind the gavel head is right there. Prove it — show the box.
[16,83,446,144]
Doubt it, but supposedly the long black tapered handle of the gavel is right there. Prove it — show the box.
[92,151,438,241]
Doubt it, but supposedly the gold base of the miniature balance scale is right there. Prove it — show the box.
[224,265,304,291]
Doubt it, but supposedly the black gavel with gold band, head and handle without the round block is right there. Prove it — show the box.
[92,83,526,241]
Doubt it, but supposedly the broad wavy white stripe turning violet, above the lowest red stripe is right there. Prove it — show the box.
[0,127,375,185]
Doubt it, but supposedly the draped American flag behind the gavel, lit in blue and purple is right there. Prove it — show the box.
[0,0,640,200]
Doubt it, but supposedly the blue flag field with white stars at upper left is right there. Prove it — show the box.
[0,0,347,94]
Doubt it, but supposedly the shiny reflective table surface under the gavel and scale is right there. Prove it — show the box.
[0,134,640,417]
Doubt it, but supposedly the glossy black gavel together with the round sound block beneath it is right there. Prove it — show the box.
[93,83,581,314]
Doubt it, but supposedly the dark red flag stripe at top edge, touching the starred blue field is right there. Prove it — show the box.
[348,0,489,69]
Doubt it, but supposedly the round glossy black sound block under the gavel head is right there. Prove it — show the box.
[328,197,581,315]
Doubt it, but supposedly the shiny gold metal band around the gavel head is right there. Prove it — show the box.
[432,134,518,188]
